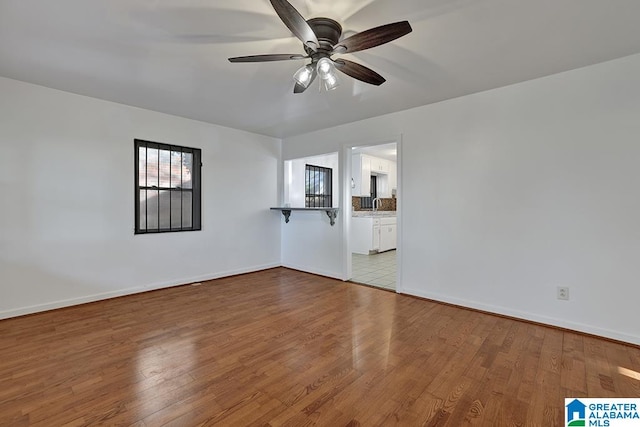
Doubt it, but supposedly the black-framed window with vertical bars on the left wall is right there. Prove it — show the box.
[134,139,201,234]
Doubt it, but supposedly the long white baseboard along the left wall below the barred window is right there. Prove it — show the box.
[0,263,280,319]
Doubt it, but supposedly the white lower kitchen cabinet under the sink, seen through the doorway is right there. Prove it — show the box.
[351,216,396,255]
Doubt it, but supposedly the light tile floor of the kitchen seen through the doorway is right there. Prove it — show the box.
[351,250,396,290]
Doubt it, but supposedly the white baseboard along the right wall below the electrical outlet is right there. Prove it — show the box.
[402,288,640,345]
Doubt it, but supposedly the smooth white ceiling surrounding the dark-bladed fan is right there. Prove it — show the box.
[0,0,640,137]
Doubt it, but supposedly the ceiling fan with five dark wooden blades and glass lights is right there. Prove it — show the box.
[229,0,412,93]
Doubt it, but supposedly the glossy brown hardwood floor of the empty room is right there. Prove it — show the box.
[0,268,640,427]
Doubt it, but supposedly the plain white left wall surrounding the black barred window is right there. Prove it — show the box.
[0,78,282,318]
